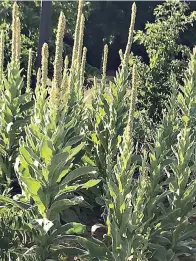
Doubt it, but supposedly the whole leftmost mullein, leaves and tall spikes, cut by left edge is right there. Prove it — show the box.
[0,3,32,193]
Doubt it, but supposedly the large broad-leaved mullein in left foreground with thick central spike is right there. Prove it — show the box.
[0,5,100,260]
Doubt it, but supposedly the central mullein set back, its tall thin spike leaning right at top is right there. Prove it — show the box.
[87,3,136,178]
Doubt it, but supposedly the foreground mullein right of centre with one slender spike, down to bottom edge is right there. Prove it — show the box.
[104,65,152,261]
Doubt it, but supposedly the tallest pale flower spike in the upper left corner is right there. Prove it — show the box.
[12,2,18,63]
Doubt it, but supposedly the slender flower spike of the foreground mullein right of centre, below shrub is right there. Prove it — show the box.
[124,64,138,144]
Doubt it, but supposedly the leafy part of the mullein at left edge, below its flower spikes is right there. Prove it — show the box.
[0,65,32,191]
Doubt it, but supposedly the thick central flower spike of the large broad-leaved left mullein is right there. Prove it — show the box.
[53,12,65,87]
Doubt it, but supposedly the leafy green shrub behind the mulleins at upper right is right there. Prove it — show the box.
[134,1,195,120]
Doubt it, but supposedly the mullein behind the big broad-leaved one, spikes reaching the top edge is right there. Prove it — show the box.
[59,0,87,144]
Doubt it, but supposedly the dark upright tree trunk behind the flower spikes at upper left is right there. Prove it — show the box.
[36,0,52,70]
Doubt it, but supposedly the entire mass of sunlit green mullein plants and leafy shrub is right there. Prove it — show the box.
[0,1,196,261]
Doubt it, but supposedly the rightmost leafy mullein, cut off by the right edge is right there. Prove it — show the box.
[160,48,196,257]
